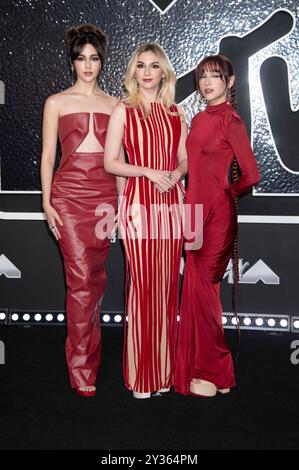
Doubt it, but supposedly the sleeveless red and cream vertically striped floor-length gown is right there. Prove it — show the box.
[120,102,183,392]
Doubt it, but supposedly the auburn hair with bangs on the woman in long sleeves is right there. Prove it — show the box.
[195,54,237,108]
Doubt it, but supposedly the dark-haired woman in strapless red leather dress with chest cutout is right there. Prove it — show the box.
[41,25,121,396]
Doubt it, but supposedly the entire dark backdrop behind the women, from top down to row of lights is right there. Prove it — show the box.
[0,0,299,324]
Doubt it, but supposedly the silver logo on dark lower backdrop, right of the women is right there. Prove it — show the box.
[223,259,280,285]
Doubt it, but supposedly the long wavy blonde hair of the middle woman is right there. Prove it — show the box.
[124,42,176,114]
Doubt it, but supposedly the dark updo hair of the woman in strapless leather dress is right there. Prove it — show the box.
[66,24,108,66]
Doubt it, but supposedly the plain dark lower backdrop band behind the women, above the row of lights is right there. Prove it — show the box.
[0,221,299,315]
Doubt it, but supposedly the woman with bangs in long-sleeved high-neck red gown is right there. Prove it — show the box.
[175,55,259,396]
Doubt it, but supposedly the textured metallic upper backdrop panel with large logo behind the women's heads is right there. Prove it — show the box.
[0,0,299,198]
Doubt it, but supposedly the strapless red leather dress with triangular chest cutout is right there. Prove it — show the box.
[51,112,117,388]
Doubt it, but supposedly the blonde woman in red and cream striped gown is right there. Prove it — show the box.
[104,43,187,398]
